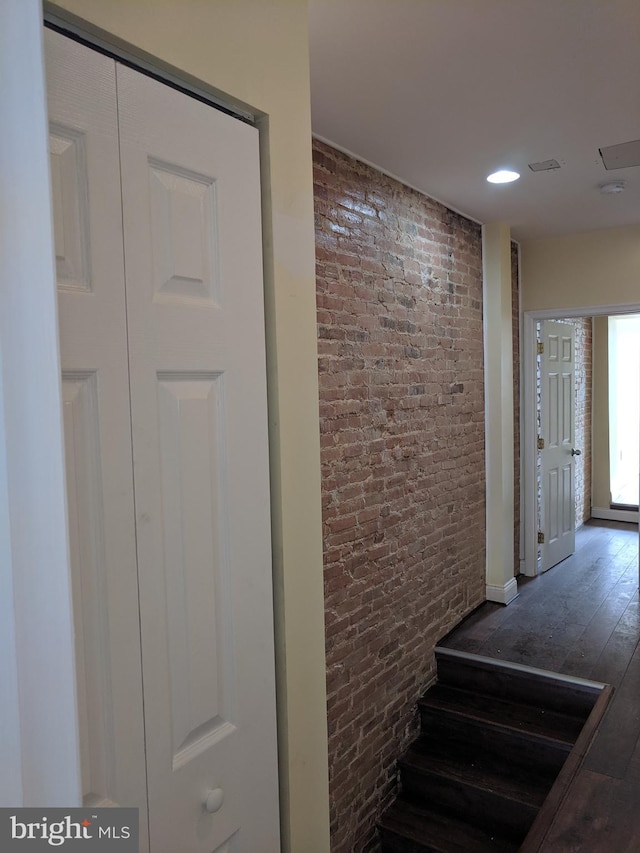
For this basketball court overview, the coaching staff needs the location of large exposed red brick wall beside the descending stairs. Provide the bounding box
[314,142,485,853]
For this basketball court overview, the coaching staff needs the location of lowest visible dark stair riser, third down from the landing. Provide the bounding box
[400,765,538,841]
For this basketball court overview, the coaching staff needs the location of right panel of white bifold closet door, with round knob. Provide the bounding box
[117,66,280,853]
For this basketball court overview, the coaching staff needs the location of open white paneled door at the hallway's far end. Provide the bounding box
[540,320,576,571]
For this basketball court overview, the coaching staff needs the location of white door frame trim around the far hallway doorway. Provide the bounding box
[520,302,640,577]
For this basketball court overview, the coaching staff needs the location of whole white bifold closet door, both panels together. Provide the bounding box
[47,28,279,853]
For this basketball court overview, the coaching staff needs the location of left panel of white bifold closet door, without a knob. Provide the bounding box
[45,30,148,851]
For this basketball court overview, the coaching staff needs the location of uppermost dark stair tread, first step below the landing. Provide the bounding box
[419,684,584,746]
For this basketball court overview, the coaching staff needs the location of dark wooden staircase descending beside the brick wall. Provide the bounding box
[378,648,610,853]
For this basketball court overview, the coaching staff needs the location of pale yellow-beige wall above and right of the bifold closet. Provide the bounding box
[45,0,329,853]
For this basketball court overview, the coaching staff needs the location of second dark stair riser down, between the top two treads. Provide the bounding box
[420,707,571,774]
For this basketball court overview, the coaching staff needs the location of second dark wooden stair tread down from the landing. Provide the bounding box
[400,735,556,809]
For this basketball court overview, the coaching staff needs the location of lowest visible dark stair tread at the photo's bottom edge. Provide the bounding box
[378,798,519,853]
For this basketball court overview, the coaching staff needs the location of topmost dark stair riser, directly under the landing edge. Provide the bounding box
[438,657,599,720]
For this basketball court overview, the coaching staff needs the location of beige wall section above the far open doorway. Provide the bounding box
[522,225,640,311]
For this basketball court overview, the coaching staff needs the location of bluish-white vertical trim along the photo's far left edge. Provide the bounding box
[0,0,82,807]
